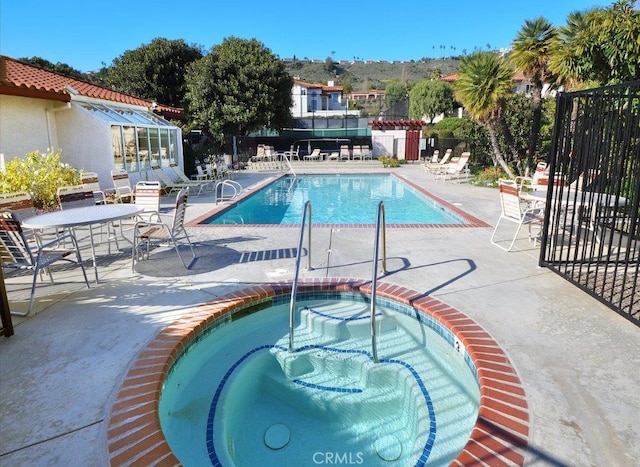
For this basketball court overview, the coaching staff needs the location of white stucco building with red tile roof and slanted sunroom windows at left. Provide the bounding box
[0,56,183,189]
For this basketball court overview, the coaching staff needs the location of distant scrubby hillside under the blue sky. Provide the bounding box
[285,58,459,90]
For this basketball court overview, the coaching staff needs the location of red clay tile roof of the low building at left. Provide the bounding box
[0,55,183,118]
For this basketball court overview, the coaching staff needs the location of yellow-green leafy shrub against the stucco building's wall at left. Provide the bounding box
[0,149,81,211]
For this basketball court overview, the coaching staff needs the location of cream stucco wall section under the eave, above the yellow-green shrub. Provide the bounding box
[0,95,61,161]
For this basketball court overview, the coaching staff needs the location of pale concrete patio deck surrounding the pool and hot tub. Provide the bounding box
[0,163,640,466]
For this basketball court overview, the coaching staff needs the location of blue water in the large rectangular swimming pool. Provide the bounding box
[205,174,464,225]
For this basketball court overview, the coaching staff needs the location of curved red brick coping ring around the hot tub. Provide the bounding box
[107,278,529,466]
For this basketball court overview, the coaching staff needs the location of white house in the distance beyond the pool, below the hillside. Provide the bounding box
[291,79,360,118]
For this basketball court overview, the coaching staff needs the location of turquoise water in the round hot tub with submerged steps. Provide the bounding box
[160,293,479,466]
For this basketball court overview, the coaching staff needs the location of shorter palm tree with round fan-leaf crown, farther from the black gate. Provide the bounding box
[453,52,522,178]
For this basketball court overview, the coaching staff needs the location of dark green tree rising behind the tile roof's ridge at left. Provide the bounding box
[104,38,202,107]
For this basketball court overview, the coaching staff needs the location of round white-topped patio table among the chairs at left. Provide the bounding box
[22,204,143,283]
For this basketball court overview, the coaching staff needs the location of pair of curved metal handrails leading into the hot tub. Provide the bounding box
[289,201,387,363]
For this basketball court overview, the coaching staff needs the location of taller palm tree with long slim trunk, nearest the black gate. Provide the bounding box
[509,17,557,174]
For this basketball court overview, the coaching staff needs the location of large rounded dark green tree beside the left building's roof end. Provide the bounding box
[186,37,293,141]
